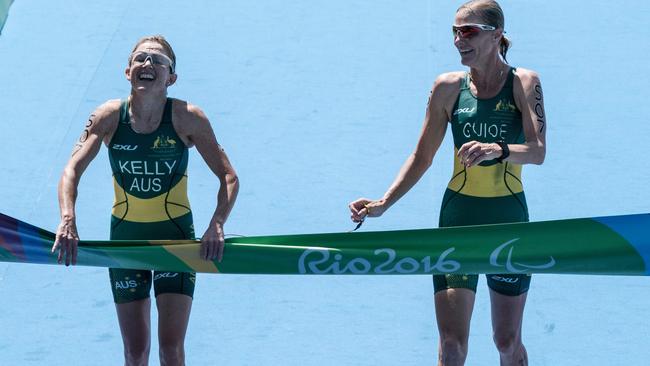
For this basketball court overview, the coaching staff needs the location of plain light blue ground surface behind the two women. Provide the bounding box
[0,0,650,365]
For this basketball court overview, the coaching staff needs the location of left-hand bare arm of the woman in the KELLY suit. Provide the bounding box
[52,102,117,266]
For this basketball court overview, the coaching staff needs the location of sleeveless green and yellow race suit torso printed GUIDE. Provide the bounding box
[440,68,528,226]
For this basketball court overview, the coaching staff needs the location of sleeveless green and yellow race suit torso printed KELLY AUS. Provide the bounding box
[108,98,194,239]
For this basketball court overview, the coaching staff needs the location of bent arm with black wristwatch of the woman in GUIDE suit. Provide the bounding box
[458,68,546,167]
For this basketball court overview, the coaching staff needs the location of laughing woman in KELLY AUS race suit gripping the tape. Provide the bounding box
[52,36,239,365]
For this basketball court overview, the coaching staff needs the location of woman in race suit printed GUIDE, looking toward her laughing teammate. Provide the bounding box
[350,0,546,365]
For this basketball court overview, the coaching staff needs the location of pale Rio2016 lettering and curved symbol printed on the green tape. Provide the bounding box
[298,238,556,274]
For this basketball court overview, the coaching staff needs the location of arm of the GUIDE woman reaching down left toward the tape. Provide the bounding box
[349,73,458,222]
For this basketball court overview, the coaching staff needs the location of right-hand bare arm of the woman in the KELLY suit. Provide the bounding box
[181,104,239,262]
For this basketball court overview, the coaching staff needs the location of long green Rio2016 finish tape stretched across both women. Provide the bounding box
[0,214,650,276]
